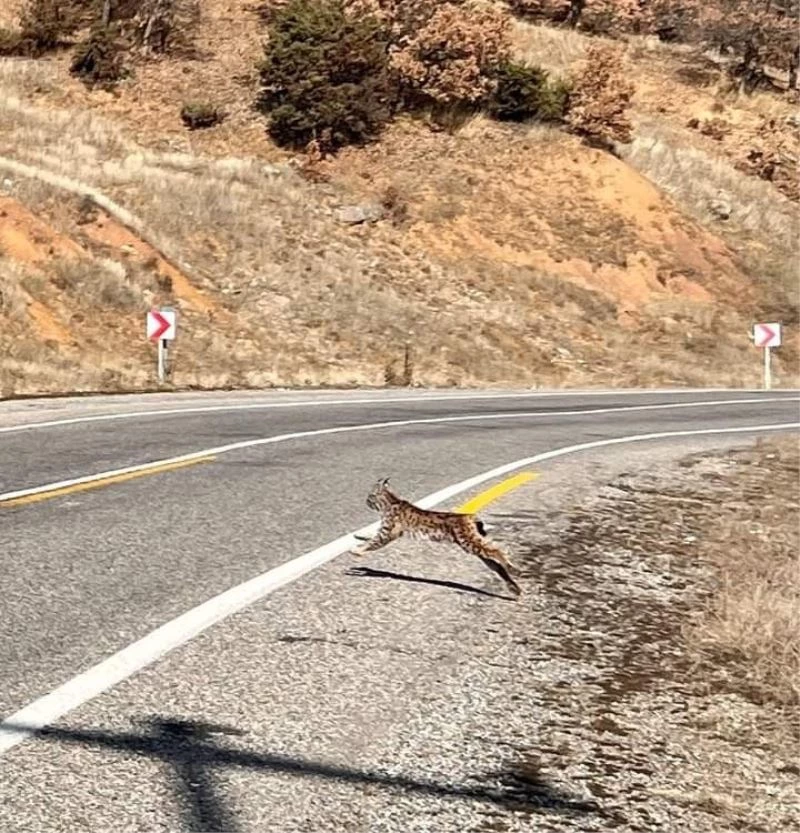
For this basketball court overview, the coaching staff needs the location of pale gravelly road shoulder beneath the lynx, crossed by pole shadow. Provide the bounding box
[0,432,800,833]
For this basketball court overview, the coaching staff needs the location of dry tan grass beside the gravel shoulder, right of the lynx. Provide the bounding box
[687,437,800,706]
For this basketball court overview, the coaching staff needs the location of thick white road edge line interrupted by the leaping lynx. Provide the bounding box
[0,422,800,755]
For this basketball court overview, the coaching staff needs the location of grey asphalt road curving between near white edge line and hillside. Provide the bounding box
[0,391,800,829]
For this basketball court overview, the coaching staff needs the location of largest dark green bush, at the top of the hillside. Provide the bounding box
[258,0,394,152]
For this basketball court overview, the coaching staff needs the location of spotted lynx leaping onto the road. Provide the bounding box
[351,477,522,596]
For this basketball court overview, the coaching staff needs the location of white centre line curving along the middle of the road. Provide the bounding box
[0,397,800,505]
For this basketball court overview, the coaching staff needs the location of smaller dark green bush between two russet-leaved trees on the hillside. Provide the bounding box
[487,63,569,122]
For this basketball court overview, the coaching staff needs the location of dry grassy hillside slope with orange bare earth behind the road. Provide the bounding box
[0,0,797,395]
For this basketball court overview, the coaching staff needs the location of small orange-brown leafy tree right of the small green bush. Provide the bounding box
[567,43,635,146]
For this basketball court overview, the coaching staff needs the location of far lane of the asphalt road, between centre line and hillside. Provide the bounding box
[0,391,792,492]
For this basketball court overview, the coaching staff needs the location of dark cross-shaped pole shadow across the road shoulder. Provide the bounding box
[5,717,604,833]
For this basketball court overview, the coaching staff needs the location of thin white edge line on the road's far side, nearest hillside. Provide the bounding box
[0,388,793,434]
